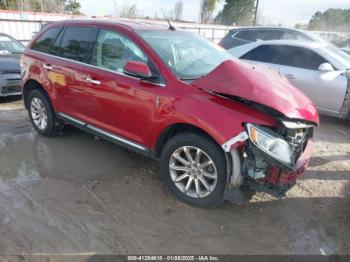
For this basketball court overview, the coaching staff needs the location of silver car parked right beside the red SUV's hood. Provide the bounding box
[229,40,350,118]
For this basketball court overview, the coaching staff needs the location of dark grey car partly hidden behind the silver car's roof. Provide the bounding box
[219,27,327,49]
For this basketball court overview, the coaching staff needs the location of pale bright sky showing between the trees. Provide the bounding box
[80,0,350,26]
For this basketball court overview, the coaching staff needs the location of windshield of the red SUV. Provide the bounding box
[138,30,234,80]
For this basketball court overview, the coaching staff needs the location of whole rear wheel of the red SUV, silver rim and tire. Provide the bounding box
[28,89,63,137]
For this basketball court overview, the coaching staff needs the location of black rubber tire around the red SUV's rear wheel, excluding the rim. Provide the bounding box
[28,90,55,136]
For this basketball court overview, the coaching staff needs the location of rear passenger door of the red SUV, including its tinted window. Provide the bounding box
[48,26,98,120]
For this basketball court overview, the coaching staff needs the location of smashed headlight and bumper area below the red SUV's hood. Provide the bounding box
[222,121,314,193]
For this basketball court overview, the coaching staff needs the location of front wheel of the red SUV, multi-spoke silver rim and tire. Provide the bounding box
[160,133,227,208]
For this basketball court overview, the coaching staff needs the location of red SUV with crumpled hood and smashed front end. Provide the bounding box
[21,19,319,207]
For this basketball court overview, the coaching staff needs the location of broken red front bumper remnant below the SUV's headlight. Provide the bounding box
[264,140,313,185]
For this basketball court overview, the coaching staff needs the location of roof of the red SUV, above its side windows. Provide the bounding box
[54,18,174,31]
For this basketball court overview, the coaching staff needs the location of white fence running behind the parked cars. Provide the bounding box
[0,10,350,47]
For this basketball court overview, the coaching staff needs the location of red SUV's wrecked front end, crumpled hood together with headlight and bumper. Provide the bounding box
[192,60,319,194]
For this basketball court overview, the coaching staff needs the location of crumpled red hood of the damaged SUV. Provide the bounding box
[192,60,319,124]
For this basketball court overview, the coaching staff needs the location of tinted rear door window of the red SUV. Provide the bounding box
[55,26,97,63]
